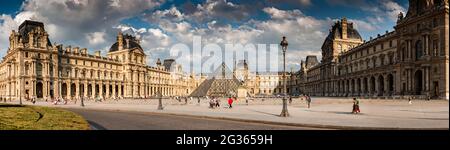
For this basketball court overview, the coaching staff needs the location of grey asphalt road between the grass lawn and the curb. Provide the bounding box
[68,109,317,130]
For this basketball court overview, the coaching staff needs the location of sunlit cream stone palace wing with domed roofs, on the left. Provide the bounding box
[0,20,198,99]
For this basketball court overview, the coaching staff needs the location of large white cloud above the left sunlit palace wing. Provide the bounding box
[2,0,163,51]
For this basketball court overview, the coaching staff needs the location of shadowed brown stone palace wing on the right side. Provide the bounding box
[296,0,449,100]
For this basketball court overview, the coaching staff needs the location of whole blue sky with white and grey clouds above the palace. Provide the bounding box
[0,0,408,72]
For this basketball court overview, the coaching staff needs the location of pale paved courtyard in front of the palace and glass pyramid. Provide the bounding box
[4,97,449,129]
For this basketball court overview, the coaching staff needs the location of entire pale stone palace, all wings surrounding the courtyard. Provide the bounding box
[0,0,449,100]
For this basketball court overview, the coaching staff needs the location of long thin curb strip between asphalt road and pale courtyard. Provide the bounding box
[65,108,449,130]
